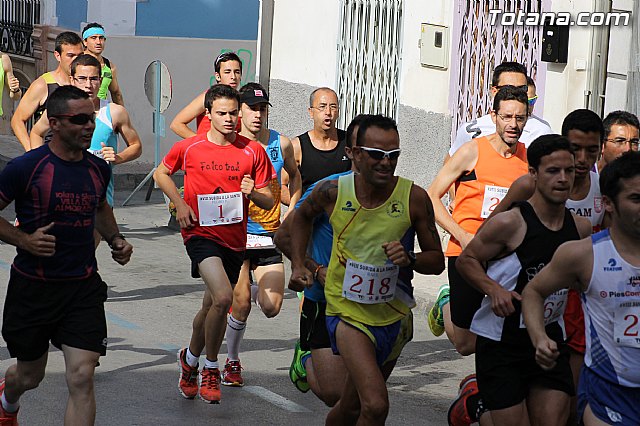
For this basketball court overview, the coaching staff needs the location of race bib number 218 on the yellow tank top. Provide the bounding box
[342,259,400,305]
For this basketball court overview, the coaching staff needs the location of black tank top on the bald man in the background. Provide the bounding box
[298,129,351,193]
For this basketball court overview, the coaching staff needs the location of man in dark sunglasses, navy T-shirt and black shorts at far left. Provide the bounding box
[0,86,133,425]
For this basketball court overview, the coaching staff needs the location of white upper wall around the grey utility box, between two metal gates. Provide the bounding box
[400,0,455,115]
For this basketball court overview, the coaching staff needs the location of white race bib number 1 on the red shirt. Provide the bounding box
[198,192,244,226]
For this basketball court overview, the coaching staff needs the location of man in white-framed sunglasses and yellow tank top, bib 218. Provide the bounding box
[290,115,444,424]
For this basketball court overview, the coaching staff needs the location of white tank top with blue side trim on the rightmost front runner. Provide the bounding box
[581,230,640,388]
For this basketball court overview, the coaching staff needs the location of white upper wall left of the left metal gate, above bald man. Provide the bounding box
[271,0,340,87]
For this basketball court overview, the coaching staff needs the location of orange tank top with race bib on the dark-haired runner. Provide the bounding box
[445,136,528,256]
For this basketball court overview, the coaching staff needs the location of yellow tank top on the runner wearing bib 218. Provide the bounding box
[324,174,413,326]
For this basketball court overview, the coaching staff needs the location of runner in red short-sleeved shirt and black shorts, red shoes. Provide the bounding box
[154,84,276,403]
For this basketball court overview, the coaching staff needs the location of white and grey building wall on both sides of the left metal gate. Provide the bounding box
[269,0,452,186]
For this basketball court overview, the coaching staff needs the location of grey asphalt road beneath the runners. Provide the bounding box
[0,190,473,425]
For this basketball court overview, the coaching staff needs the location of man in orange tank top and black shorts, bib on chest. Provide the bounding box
[428,86,528,355]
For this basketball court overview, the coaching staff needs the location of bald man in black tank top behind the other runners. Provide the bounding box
[282,87,351,201]
